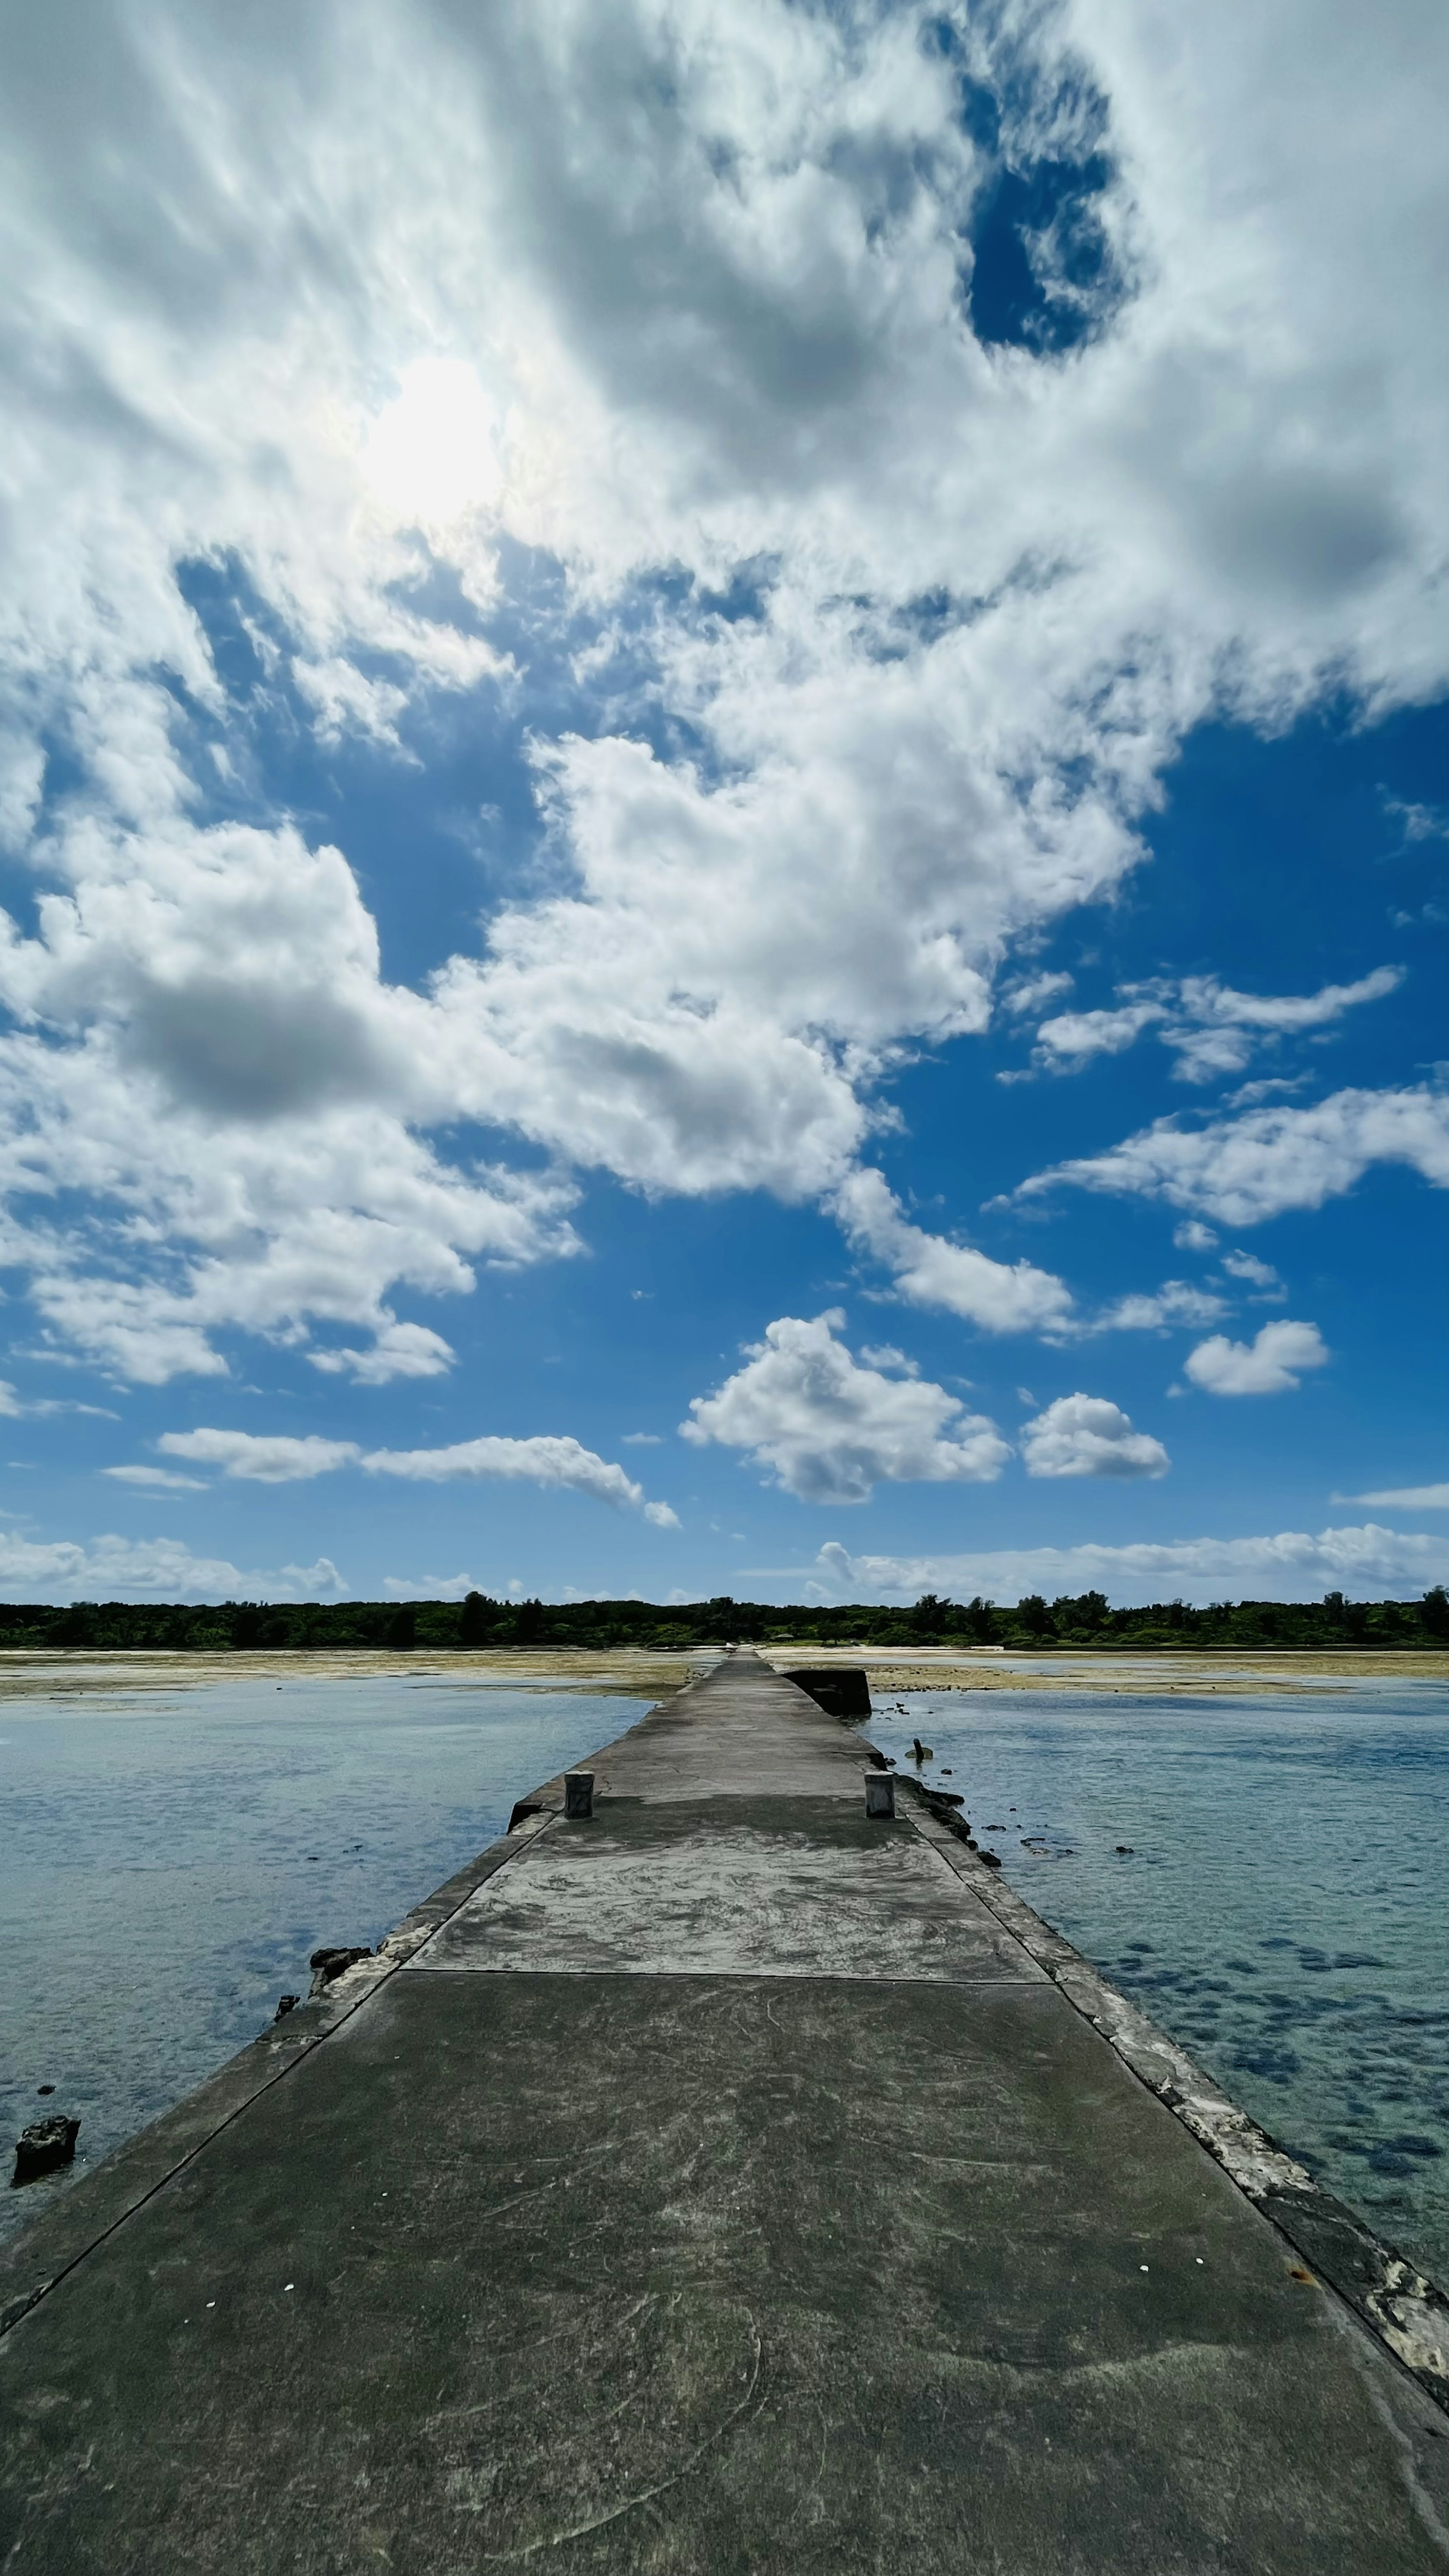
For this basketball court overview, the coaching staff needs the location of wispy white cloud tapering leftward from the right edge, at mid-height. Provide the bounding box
[1016,1084,1449,1226]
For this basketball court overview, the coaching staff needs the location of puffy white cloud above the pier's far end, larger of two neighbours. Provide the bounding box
[681,1309,1011,1502]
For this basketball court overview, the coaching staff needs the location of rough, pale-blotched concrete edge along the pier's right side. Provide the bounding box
[902,1778,1449,2414]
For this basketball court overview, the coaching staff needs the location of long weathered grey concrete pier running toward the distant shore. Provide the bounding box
[0,1654,1449,2576]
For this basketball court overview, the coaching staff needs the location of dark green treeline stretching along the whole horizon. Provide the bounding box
[11,1584,1449,1654]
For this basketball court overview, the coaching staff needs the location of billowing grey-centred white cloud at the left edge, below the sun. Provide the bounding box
[0,822,580,1383]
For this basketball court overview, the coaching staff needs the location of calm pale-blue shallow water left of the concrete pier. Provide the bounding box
[0,1675,637,2236]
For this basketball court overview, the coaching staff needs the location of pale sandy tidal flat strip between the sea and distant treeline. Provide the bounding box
[0,1638,1449,1700]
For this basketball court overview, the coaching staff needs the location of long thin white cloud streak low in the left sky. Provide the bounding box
[153,1430,678,1530]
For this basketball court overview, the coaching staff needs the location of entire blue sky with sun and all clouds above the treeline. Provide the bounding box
[0,0,1449,1600]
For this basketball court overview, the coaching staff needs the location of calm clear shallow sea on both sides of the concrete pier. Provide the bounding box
[0,1675,1449,2282]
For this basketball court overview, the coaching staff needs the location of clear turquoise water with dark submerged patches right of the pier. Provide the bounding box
[871,1682,1449,2282]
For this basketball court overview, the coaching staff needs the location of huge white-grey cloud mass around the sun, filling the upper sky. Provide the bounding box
[0,0,1444,1381]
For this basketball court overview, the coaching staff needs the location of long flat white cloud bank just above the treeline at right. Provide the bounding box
[799,1520,1449,1605]
